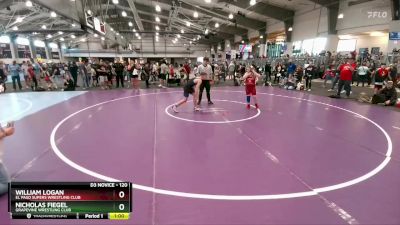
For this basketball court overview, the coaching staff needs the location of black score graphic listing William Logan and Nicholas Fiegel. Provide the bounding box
[8,182,132,220]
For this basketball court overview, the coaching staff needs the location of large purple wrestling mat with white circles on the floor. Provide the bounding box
[0,87,400,224]
